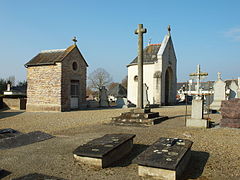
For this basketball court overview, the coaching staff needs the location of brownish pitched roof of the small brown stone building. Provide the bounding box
[25,44,88,67]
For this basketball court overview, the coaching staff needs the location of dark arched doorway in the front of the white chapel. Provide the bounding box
[164,67,173,105]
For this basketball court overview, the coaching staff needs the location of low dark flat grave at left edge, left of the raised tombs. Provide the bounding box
[0,129,54,150]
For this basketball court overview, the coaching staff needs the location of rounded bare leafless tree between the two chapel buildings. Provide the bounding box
[88,68,112,90]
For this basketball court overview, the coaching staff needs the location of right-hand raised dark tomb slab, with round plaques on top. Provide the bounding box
[136,137,193,180]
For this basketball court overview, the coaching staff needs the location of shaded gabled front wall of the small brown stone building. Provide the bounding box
[61,48,87,111]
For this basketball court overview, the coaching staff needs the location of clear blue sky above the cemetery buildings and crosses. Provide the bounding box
[0,0,240,82]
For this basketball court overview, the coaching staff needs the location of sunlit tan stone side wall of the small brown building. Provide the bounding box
[26,63,62,111]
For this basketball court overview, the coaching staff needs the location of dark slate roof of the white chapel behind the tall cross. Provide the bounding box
[128,44,161,66]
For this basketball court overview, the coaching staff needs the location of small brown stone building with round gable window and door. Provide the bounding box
[25,40,88,111]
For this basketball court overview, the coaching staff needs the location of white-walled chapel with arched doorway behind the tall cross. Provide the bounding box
[127,26,177,105]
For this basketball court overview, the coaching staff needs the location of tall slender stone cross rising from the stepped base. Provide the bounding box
[135,24,147,109]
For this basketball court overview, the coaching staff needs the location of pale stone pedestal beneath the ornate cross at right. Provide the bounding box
[186,99,208,128]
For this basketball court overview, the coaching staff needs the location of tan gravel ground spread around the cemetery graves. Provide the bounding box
[0,106,240,180]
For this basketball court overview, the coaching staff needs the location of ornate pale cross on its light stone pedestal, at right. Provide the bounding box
[186,65,208,128]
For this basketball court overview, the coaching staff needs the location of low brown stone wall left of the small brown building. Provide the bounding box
[3,98,27,110]
